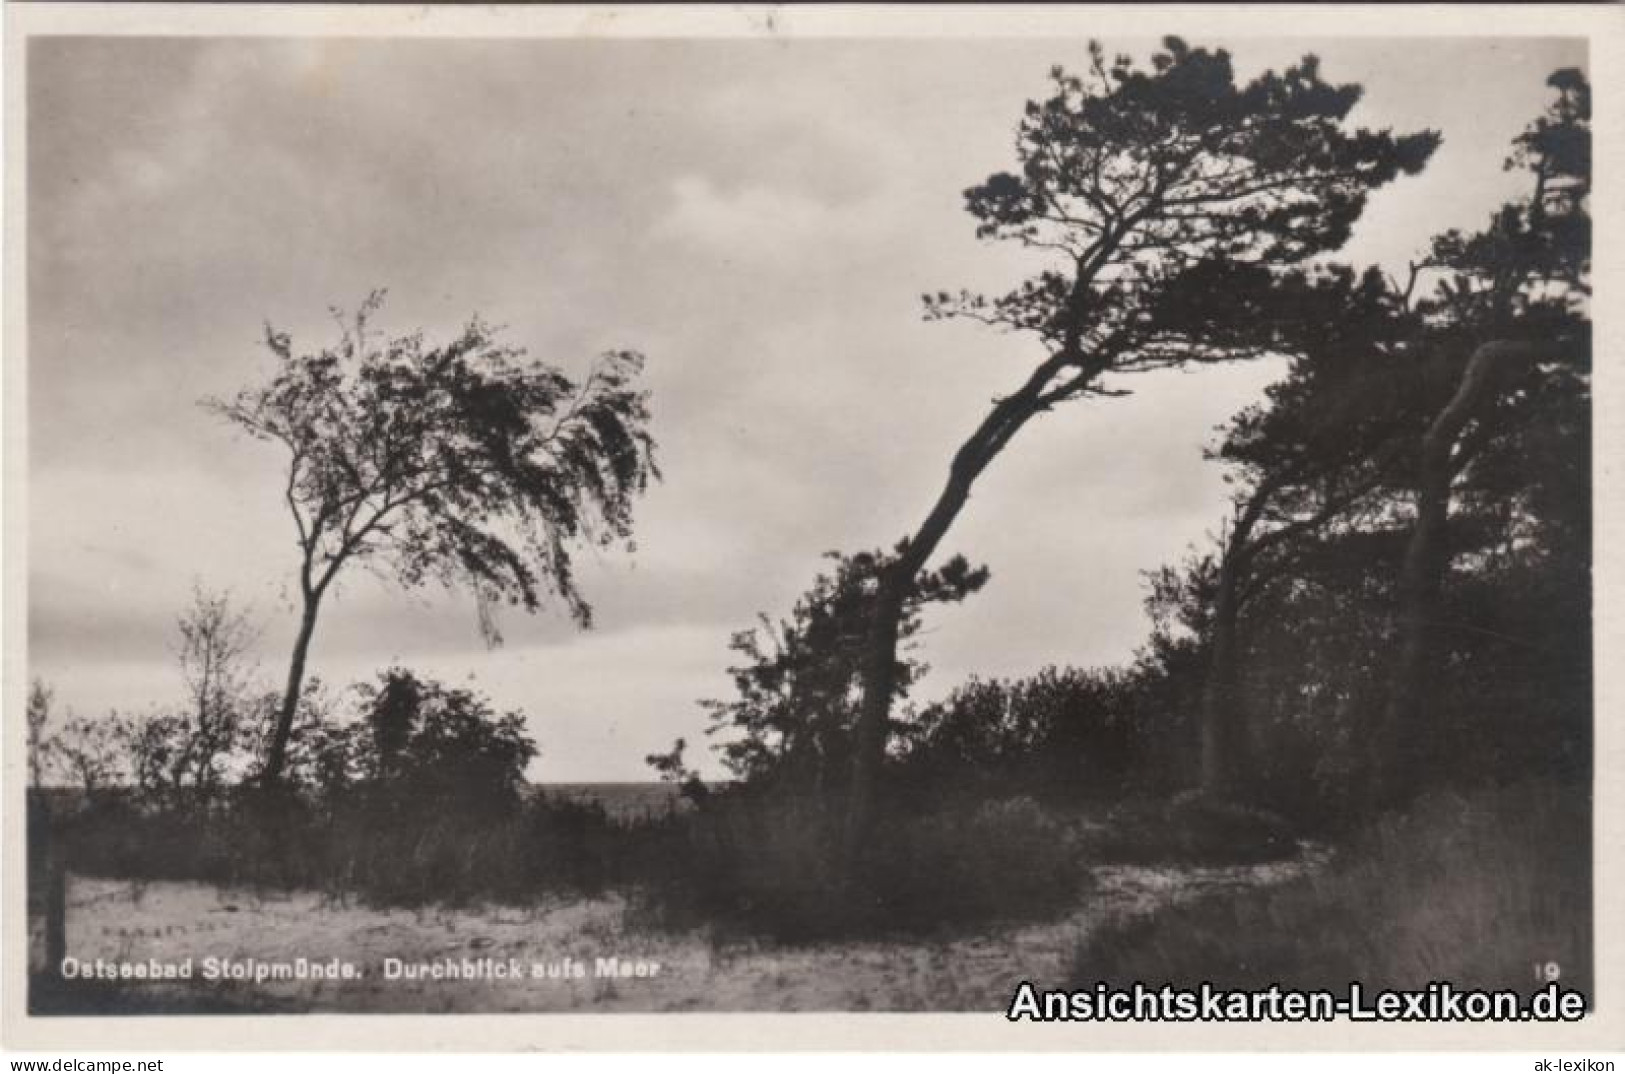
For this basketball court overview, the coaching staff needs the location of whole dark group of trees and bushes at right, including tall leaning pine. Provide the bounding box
[710,54,1591,827]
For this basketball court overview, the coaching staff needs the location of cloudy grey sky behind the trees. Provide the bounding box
[28,29,1584,780]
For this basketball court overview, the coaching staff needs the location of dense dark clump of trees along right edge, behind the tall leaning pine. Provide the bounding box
[1105,64,1591,824]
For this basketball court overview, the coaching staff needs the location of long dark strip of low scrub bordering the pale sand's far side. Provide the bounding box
[54,786,1086,941]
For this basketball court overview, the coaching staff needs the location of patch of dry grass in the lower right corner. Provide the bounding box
[1073,783,1593,991]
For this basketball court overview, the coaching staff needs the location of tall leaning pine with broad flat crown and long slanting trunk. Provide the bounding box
[848,37,1438,855]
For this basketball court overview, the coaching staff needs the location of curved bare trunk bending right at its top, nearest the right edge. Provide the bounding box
[1372,341,1534,804]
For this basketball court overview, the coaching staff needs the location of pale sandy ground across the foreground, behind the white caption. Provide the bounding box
[44,861,1313,1012]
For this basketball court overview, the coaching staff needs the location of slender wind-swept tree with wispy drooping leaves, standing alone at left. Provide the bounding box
[205,291,660,783]
